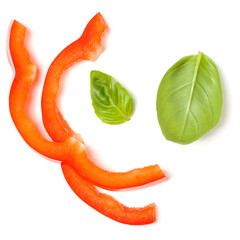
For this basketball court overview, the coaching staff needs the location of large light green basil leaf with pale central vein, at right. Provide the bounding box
[156,52,222,144]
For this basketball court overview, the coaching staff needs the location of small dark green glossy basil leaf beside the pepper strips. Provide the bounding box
[90,71,133,124]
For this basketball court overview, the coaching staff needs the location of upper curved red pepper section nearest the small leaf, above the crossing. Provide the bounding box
[42,13,108,142]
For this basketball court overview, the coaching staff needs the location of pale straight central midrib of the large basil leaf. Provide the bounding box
[180,52,203,141]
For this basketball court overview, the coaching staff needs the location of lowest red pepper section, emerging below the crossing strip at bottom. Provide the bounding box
[61,163,156,225]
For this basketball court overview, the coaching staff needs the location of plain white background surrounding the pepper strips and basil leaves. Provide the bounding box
[0,0,240,240]
